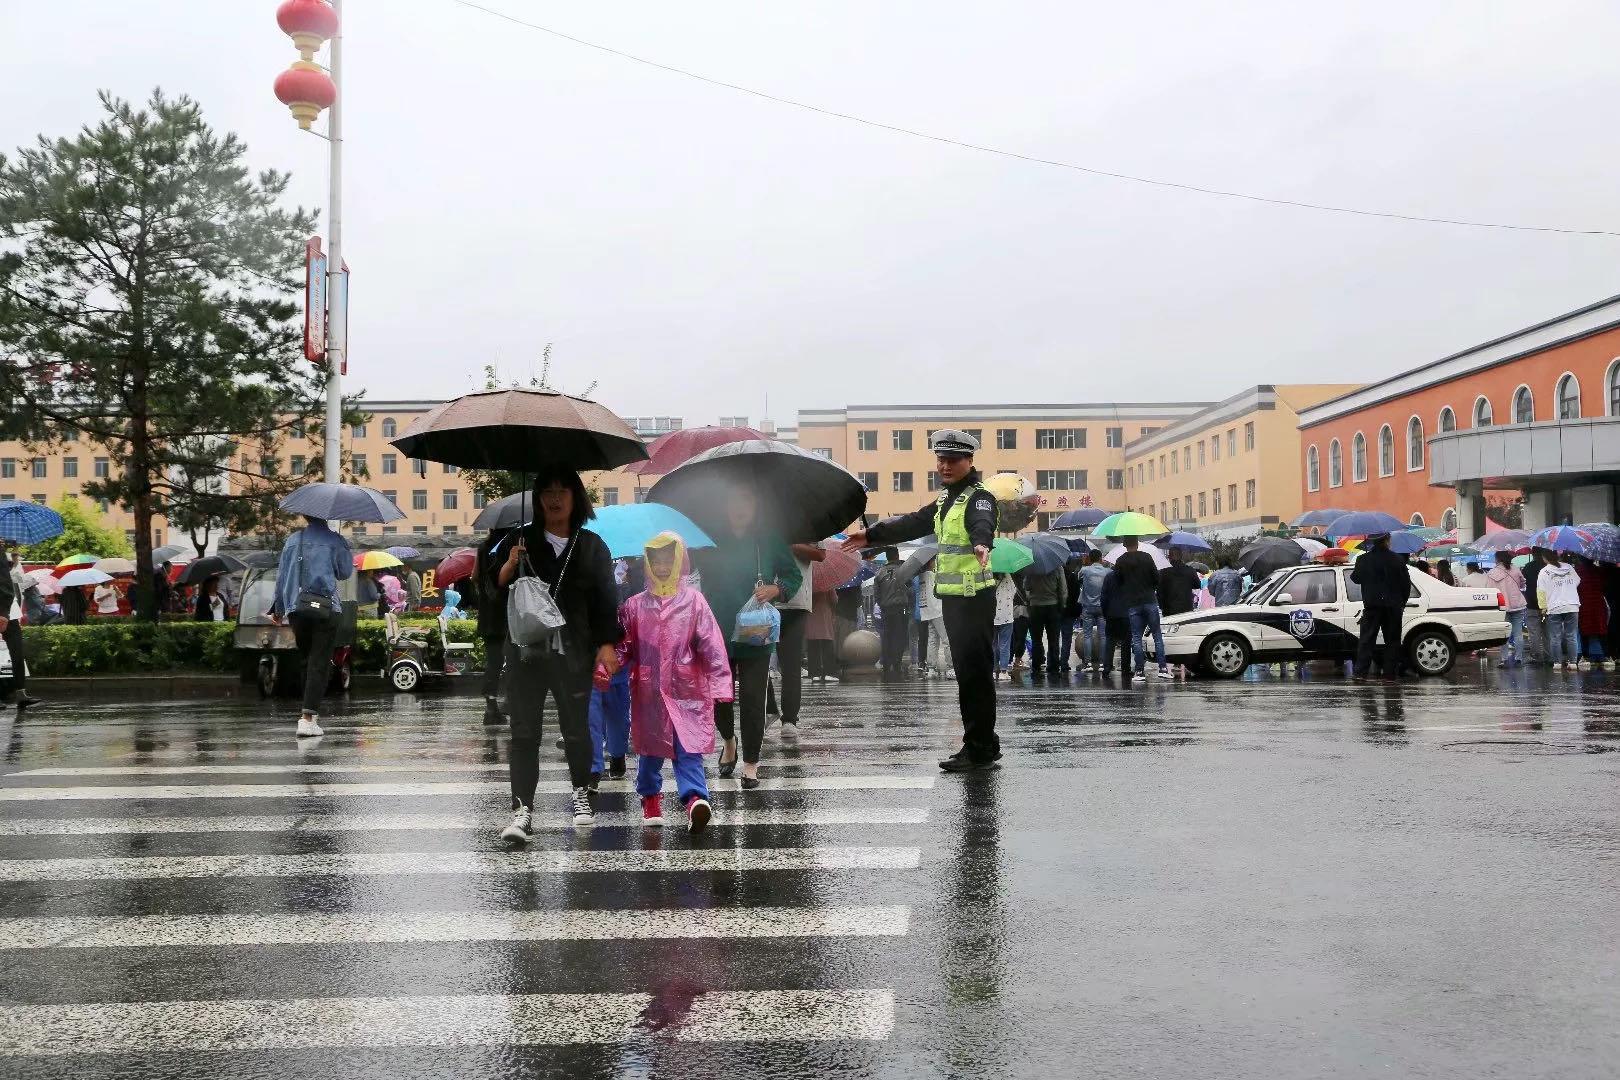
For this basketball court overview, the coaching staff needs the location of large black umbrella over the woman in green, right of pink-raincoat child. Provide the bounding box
[648,439,867,544]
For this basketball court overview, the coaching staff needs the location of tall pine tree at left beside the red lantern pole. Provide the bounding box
[0,91,326,619]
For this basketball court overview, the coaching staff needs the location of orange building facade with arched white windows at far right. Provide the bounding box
[1299,296,1620,539]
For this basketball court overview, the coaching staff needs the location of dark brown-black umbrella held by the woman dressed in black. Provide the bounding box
[394,390,646,473]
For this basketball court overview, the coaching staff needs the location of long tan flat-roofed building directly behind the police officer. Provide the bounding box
[795,402,1209,528]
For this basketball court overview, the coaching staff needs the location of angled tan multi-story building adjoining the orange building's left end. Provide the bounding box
[1119,384,1356,536]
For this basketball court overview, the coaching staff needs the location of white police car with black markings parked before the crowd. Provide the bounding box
[1147,565,1508,678]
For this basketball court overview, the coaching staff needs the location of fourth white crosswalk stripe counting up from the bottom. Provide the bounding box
[0,806,928,836]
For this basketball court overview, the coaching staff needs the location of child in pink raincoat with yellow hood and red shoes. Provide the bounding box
[619,533,732,832]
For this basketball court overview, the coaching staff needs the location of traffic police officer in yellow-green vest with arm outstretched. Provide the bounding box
[844,429,1001,772]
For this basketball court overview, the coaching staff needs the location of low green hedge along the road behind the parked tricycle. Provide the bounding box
[23,615,484,675]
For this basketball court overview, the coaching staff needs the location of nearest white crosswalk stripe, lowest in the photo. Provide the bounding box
[0,989,894,1056]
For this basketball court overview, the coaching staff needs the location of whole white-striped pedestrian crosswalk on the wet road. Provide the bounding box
[0,711,938,1077]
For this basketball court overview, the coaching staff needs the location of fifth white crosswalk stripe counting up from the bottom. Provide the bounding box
[0,774,935,803]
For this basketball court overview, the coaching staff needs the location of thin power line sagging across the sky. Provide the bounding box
[450,0,1620,236]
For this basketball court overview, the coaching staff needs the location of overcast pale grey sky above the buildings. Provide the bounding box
[0,0,1620,424]
